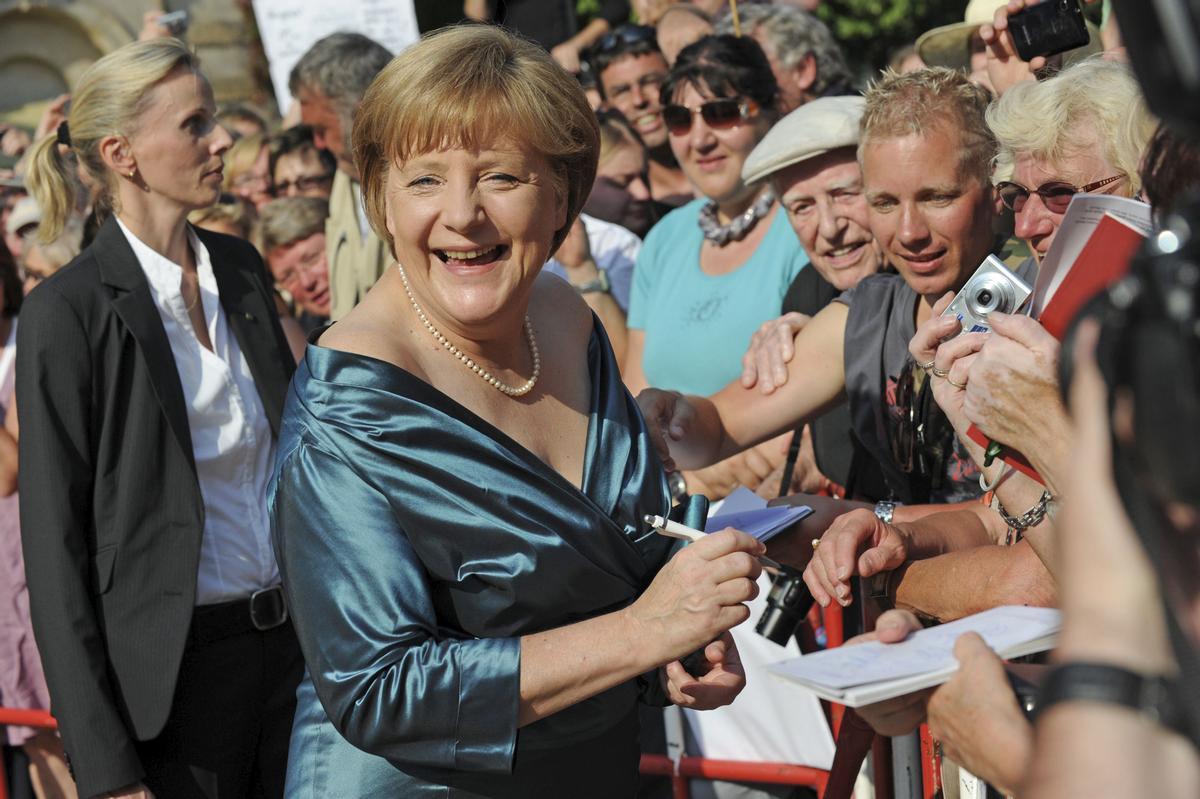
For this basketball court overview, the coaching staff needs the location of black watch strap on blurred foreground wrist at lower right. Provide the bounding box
[1036,662,1182,731]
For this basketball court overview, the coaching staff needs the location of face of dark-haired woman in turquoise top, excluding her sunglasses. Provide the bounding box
[670,84,770,204]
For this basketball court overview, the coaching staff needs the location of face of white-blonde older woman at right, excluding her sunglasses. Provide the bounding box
[1013,146,1129,264]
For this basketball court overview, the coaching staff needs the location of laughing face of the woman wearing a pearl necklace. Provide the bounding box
[386,139,566,333]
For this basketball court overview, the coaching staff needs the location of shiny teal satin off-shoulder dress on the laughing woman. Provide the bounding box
[270,323,671,799]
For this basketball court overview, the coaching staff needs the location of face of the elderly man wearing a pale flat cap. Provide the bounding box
[772,148,883,290]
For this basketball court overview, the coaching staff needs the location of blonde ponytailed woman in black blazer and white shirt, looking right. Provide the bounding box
[17,40,301,799]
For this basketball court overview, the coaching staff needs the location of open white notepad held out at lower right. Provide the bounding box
[770,606,1062,708]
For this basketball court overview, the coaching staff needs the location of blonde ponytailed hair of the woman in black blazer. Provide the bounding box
[25,38,199,242]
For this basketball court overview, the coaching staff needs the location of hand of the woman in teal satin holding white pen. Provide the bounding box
[624,528,767,665]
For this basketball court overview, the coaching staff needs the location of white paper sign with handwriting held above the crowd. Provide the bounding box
[253,0,420,114]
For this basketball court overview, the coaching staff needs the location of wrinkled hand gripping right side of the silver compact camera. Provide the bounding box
[961,313,1067,452]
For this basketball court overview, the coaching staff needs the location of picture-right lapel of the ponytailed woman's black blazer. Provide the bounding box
[197,230,292,438]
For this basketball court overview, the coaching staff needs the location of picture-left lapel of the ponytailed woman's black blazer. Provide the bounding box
[92,217,196,471]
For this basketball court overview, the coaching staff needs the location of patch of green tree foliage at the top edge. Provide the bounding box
[817,0,969,73]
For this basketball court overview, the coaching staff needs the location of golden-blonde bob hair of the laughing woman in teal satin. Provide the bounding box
[353,25,599,256]
